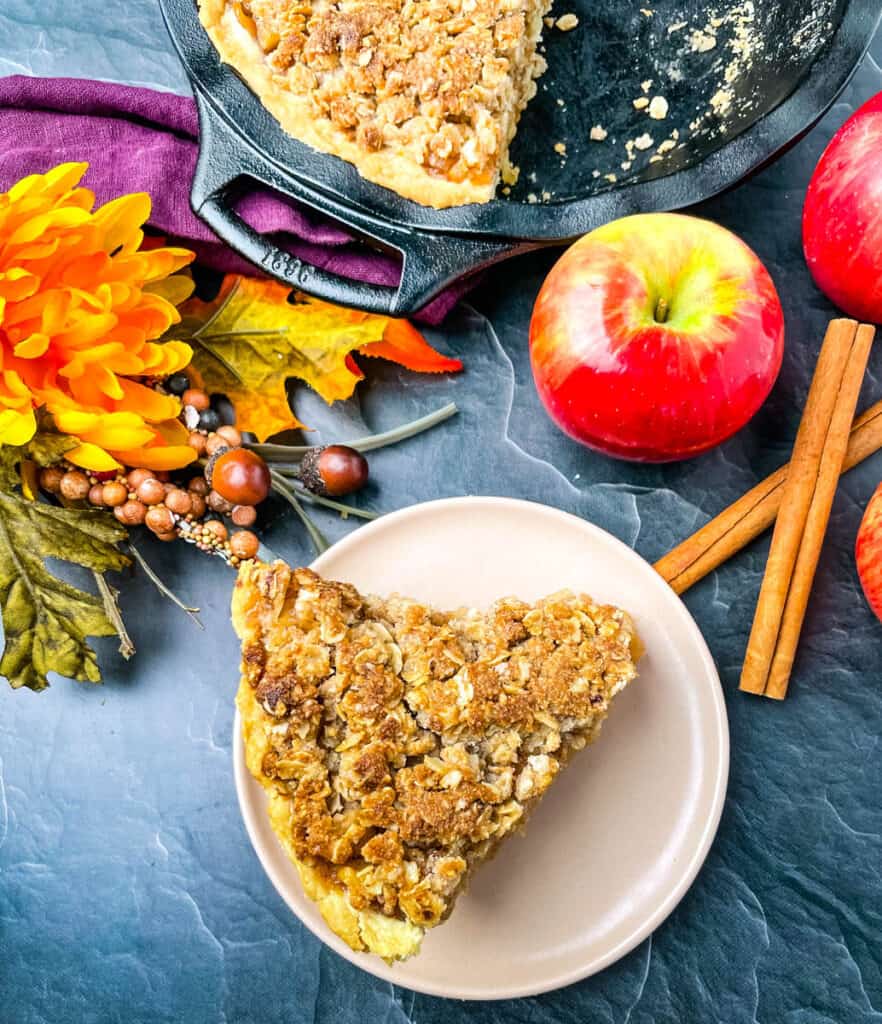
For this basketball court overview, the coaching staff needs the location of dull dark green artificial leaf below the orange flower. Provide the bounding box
[0,445,128,690]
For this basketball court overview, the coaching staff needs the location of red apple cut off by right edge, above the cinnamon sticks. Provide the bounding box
[802,92,882,324]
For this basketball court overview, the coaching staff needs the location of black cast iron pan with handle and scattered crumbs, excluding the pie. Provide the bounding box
[160,0,882,315]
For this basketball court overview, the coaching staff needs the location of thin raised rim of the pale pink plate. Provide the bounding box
[233,496,730,1001]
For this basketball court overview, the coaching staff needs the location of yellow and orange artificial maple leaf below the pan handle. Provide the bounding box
[183,274,462,441]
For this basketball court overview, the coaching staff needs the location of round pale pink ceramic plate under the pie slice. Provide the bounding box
[234,498,728,999]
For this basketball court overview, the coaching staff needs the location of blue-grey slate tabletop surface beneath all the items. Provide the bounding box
[0,8,882,1024]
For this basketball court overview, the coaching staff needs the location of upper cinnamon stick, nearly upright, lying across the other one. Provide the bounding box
[741,319,875,699]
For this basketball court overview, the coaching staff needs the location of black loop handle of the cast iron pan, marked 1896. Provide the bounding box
[191,89,536,316]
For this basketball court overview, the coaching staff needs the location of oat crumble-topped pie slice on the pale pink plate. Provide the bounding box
[233,562,639,961]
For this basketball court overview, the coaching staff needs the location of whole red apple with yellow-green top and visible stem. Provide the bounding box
[530,213,784,462]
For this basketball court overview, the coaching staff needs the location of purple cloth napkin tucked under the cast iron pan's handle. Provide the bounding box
[0,75,470,324]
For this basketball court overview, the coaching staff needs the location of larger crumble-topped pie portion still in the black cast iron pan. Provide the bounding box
[199,0,551,208]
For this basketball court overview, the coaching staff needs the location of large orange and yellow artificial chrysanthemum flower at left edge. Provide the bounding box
[0,164,195,471]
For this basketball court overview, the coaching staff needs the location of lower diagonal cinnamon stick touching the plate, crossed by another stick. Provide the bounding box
[655,401,882,594]
